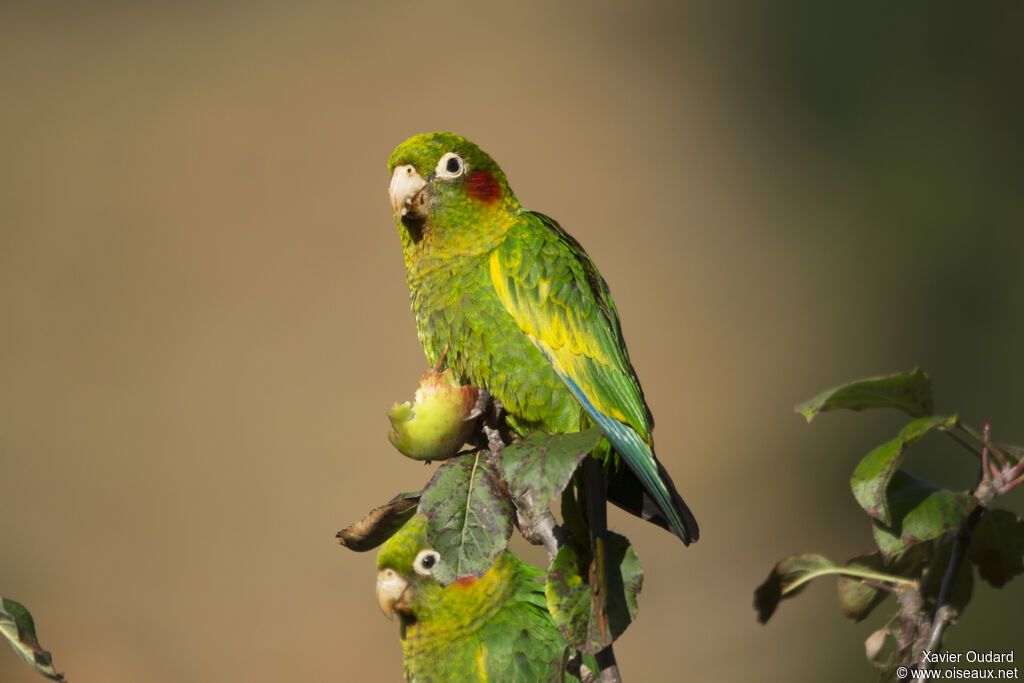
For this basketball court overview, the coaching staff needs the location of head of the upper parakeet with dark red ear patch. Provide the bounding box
[388,133,519,248]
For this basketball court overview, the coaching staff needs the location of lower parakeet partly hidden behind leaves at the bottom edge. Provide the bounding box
[377,515,567,683]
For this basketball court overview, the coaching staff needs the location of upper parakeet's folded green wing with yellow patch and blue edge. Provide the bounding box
[489,212,698,544]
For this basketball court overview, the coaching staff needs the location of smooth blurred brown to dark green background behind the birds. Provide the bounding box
[0,0,1024,683]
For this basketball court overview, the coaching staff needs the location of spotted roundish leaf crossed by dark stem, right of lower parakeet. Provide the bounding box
[545,531,643,654]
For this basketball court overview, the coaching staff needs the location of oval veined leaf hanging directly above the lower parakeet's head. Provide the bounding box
[419,452,514,586]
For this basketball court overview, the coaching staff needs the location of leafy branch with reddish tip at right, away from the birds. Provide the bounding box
[754,369,1024,681]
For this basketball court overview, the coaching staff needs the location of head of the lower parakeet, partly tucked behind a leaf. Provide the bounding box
[377,515,442,622]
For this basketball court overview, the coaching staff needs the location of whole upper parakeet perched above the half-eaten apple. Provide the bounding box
[388,133,698,545]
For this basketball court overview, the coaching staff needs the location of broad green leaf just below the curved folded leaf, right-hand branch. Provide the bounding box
[872,470,974,562]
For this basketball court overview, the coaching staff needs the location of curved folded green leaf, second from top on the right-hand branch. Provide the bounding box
[850,415,956,524]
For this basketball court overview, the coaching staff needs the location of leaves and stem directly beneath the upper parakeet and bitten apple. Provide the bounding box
[338,389,643,681]
